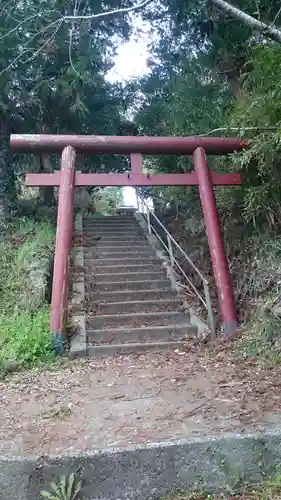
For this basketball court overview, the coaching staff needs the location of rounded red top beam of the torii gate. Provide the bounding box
[10,134,249,155]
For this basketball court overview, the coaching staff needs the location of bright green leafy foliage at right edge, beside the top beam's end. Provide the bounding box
[219,46,281,231]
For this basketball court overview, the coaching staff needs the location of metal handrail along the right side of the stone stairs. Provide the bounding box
[137,195,216,337]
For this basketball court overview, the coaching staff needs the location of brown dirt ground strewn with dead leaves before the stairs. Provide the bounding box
[0,345,281,457]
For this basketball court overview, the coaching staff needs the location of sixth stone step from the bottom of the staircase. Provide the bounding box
[85,279,171,293]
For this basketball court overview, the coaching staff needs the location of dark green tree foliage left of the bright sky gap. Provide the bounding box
[0,0,137,198]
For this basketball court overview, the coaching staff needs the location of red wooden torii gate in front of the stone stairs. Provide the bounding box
[10,134,246,350]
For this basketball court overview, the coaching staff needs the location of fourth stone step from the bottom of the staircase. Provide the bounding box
[91,298,180,315]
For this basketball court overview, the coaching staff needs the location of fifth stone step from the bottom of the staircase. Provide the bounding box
[86,286,176,304]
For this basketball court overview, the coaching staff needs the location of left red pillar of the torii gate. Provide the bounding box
[51,146,76,354]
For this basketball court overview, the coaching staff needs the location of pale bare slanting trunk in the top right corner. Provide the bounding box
[212,0,281,43]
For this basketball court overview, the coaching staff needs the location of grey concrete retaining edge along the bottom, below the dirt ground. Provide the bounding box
[0,427,281,500]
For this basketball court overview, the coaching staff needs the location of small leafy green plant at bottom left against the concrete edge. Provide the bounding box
[41,474,82,500]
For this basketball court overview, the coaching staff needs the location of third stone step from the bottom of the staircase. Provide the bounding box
[87,311,189,330]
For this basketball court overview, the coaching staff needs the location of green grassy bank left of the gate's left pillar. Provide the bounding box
[0,218,55,374]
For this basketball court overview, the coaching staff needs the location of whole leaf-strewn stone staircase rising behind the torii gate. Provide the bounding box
[83,213,197,356]
